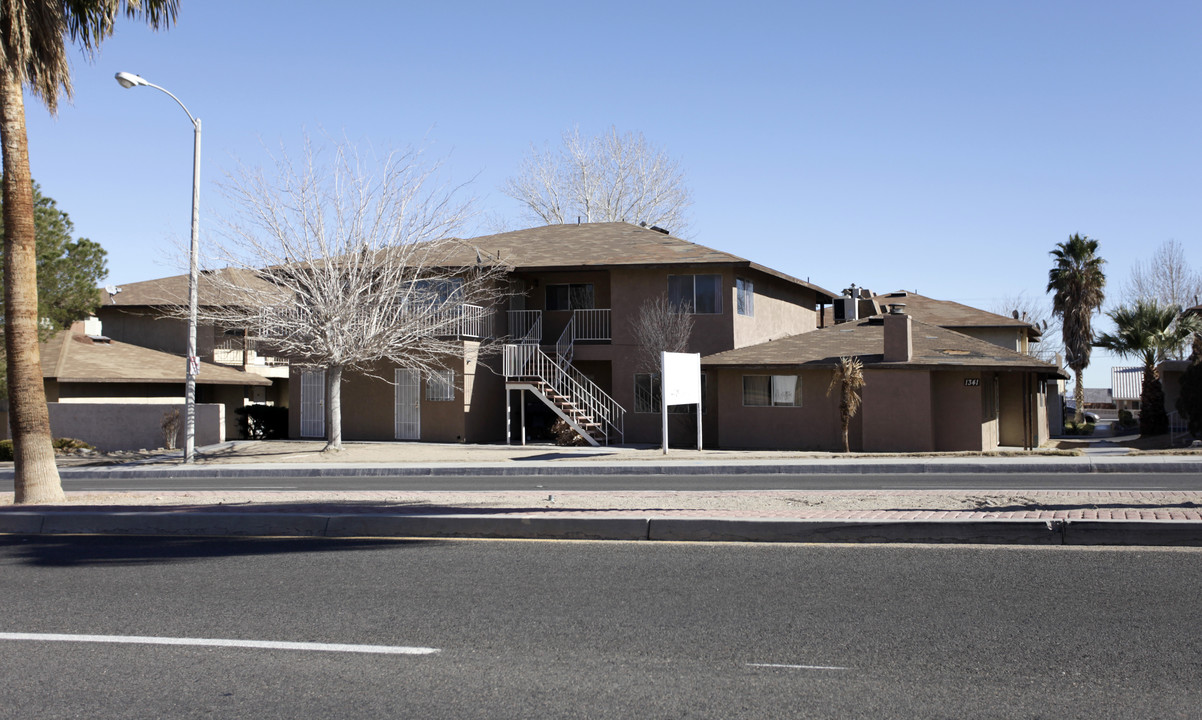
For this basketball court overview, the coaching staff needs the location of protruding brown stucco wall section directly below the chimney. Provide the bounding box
[861,369,935,452]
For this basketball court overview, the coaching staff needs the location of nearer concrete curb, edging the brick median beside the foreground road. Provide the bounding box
[7,512,1202,547]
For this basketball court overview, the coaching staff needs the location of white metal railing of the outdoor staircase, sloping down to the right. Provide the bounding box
[504,345,626,444]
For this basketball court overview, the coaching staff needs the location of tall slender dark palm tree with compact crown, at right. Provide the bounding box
[1047,234,1106,424]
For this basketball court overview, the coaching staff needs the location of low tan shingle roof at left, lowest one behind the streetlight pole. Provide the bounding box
[42,331,272,386]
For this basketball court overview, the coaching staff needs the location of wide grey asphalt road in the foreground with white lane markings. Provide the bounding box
[0,536,1202,719]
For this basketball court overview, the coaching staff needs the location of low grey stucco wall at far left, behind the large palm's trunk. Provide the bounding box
[0,403,226,452]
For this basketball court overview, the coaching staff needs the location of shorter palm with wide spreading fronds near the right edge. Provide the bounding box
[1095,301,1202,435]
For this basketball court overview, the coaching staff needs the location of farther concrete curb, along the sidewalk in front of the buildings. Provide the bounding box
[25,458,1202,480]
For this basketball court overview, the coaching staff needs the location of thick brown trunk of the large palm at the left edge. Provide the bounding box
[0,67,66,505]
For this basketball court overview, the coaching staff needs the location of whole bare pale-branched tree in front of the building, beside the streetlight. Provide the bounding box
[188,139,506,450]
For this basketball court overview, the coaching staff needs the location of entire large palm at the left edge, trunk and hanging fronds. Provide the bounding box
[0,0,179,504]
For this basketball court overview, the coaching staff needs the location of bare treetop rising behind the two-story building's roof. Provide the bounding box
[502,127,692,237]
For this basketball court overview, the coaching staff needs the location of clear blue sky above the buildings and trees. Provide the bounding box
[26,0,1202,387]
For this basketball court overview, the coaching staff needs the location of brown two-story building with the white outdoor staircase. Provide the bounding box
[290,222,832,442]
